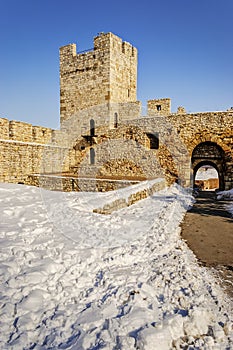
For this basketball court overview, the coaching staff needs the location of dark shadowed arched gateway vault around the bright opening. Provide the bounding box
[192,141,225,190]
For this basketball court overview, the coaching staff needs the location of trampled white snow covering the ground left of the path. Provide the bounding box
[0,184,233,350]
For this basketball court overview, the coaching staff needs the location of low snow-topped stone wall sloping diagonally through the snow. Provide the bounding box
[93,179,166,214]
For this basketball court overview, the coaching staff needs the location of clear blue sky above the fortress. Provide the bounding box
[0,0,233,128]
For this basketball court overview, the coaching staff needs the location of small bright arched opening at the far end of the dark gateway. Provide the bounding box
[194,164,219,191]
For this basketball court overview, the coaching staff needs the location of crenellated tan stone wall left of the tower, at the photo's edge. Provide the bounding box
[0,118,75,184]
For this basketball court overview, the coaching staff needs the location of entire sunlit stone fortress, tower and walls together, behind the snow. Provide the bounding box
[0,33,233,191]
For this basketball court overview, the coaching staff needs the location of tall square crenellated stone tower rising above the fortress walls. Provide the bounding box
[60,33,137,123]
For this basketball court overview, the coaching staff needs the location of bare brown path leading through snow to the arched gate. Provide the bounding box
[181,191,233,297]
